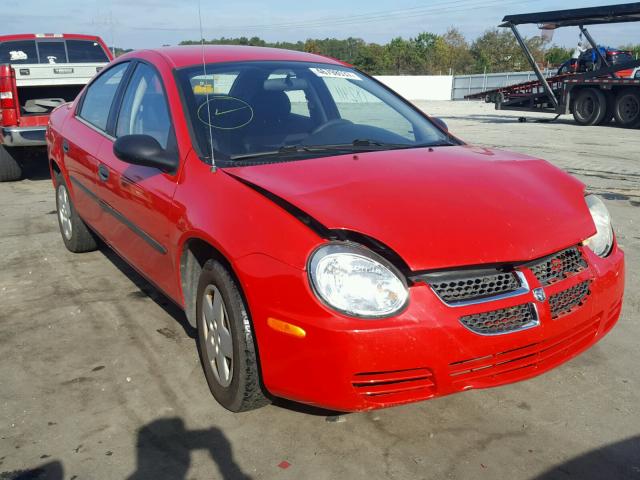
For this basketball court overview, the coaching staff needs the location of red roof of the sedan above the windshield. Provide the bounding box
[125,45,349,68]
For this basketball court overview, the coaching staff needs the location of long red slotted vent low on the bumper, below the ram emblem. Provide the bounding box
[449,314,602,389]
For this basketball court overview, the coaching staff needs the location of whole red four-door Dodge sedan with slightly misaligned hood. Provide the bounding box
[47,46,624,411]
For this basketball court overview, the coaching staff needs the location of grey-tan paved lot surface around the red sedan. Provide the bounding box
[0,102,640,480]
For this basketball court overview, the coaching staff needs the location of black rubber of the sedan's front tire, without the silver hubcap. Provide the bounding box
[196,260,257,412]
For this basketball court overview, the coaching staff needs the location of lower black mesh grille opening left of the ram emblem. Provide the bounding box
[460,303,538,335]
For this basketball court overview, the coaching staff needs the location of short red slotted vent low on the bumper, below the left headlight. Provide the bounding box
[351,368,436,402]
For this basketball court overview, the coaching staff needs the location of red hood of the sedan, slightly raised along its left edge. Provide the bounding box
[227,146,595,271]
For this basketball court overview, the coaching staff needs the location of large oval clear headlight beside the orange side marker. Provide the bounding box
[309,243,409,318]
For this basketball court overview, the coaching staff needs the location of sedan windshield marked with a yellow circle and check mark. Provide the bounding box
[179,62,458,166]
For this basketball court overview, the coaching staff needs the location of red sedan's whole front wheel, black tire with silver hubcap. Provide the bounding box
[196,260,269,412]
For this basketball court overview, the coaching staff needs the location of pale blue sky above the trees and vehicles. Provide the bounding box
[5,0,640,49]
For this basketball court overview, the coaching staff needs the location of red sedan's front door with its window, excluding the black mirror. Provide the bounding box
[90,62,179,294]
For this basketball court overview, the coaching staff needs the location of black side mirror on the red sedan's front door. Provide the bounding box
[113,135,178,173]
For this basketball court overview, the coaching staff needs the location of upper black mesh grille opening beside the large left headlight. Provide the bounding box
[427,270,521,303]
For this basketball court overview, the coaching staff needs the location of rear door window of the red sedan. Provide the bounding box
[78,62,129,131]
